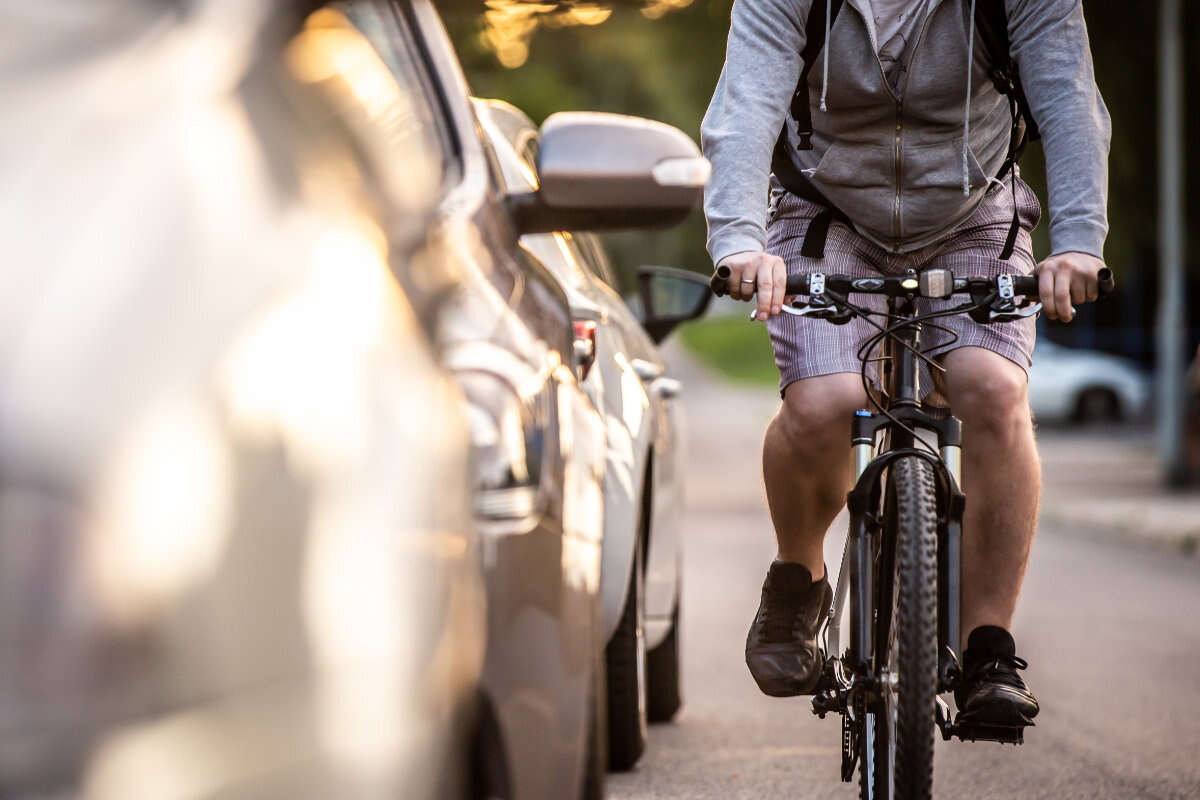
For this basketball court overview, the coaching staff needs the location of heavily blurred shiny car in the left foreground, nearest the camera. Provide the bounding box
[0,1,485,800]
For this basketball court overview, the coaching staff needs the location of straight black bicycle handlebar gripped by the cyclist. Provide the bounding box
[708,266,1115,299]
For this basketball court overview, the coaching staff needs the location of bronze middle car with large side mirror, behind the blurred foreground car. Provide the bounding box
[364,0,708,800]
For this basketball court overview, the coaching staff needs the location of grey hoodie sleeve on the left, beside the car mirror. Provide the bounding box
[701,0,812,264]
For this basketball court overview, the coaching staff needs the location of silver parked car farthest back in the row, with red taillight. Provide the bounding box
[475,100,712,770]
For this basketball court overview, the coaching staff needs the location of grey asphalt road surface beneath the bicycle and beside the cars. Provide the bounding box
[610,357,1200,800]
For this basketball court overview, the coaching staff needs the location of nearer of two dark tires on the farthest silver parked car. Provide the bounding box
[605,536,646,772]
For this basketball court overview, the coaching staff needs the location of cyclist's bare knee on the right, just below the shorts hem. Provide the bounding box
[946,348,1031,437]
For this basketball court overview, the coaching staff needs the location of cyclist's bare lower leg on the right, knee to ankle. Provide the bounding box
[946,348,1042,636]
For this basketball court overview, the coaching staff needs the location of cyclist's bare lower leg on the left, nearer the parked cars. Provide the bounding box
[762,373,866,578]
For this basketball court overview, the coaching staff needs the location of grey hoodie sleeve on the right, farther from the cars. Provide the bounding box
[1004,0,1111,258]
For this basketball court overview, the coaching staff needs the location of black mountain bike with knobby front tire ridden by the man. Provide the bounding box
[710,267,1114,800]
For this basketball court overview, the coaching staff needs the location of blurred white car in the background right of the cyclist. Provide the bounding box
[1030,337,1151,422]
